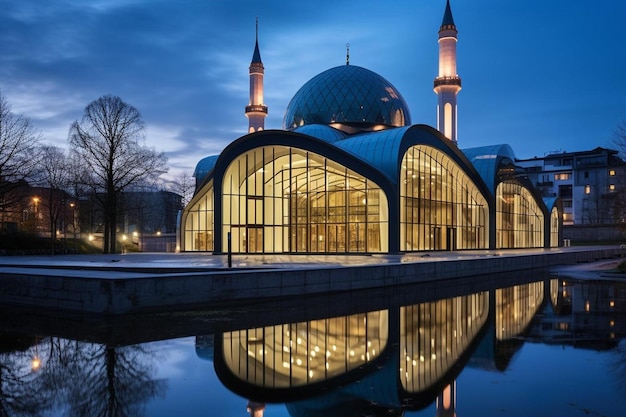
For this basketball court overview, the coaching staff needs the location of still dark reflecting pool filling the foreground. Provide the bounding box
[0,272,626,417]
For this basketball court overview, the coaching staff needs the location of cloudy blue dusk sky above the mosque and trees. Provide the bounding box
[0,0,626,180]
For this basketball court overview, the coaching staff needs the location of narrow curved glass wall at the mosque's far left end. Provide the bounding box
[181,181,215,251]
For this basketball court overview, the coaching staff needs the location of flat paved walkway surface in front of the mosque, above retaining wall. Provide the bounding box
[0,246,626,278]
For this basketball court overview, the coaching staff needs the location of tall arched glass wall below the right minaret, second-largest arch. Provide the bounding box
[400,145,489,251]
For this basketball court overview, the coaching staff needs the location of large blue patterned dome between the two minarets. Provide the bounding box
[283,65,411,130]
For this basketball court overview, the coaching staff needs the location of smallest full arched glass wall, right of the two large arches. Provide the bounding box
[496,181,544,249]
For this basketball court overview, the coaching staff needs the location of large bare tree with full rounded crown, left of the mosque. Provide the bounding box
[69,95,167,253]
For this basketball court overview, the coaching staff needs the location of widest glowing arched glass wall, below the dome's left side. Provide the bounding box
[223,146,389,253]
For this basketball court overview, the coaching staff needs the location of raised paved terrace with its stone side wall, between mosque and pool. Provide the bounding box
[0,246,624,314]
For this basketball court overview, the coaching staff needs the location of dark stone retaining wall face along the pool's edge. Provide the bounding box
[0,247,624,314]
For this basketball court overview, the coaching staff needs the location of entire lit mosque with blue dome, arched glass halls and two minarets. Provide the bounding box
[180,0,562,254]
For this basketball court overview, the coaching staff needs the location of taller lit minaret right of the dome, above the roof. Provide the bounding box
[434,0,461,143]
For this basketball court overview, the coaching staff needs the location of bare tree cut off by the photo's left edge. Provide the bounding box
[0,92,40,221]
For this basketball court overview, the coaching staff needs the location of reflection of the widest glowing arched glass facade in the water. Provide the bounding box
[222,310,389,388]
